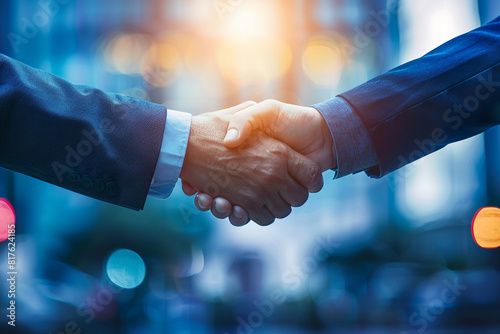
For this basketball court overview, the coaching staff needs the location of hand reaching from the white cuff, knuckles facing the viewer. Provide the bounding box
[181,104,323,225]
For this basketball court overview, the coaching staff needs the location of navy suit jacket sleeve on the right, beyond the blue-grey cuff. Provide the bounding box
[316,17,500,177]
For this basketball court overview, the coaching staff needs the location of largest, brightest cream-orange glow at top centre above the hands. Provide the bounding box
[215,1,292,85]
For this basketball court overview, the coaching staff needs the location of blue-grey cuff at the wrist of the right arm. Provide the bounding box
[312,96,378,178]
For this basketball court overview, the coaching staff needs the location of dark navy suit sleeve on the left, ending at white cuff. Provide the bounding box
[0,55,166,210]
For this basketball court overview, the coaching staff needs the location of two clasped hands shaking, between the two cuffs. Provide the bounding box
[180,100,336,226]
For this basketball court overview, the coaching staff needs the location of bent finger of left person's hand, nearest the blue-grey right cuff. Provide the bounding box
[288,149,323,192]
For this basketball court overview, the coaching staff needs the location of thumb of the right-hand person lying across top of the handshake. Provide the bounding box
[224,100,279,148]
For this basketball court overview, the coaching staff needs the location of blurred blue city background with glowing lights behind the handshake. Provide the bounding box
[0,0,500,334]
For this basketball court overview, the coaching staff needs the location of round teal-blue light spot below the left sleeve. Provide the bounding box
[106,249,146,289]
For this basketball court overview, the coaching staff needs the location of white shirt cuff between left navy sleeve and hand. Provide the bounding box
[148,110,191,199]
